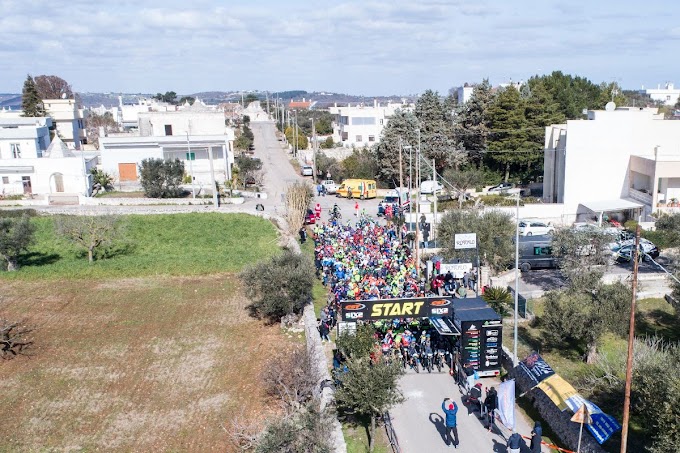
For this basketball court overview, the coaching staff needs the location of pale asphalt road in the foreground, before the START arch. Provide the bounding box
[390,371,548,453]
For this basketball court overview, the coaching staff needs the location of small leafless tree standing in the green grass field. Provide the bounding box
[55,215,123,264]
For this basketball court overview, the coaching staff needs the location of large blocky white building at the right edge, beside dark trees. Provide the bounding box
[543,108,680,220]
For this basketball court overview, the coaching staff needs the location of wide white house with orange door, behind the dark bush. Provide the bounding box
[99,103,234,185]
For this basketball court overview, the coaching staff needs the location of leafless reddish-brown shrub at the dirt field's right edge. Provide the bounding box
[262,347,316,412]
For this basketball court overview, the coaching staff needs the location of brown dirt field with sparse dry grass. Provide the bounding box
[0,274,293,452]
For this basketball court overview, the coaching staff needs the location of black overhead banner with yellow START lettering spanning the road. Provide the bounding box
[340,297,453,321]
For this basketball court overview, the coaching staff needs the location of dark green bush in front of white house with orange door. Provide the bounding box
[139,159,184,198]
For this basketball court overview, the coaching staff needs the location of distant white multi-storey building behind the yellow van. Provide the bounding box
[330,101,413,148]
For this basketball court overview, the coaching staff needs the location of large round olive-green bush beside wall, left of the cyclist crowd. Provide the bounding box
[240,250,314,322]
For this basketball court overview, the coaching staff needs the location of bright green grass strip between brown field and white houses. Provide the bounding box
[0,213,277,280]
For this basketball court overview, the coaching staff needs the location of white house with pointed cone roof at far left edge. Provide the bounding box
[0,117,96,196]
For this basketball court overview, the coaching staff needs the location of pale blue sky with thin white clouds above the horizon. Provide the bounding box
[0,0,680,96]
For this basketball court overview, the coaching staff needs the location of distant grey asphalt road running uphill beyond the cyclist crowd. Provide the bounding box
[246,121,378,221]
